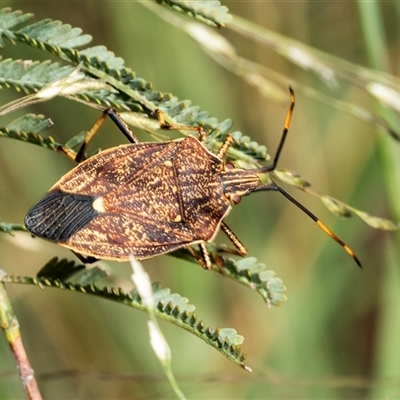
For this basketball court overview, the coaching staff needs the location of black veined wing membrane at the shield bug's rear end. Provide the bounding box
[24,189,98,242]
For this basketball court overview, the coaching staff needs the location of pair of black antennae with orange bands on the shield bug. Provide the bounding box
[254,87,362,268]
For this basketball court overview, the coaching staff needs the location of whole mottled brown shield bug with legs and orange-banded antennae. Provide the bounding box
[24,89,361,269]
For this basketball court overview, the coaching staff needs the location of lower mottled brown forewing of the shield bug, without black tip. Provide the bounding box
[60,213,196,261]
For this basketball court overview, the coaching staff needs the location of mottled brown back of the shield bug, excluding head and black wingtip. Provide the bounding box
[53,137,230,260]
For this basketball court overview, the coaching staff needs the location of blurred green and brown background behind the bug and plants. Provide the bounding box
[0,1,400,399]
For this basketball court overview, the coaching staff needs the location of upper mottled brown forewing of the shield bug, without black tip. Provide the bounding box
[53,142,176,196]
